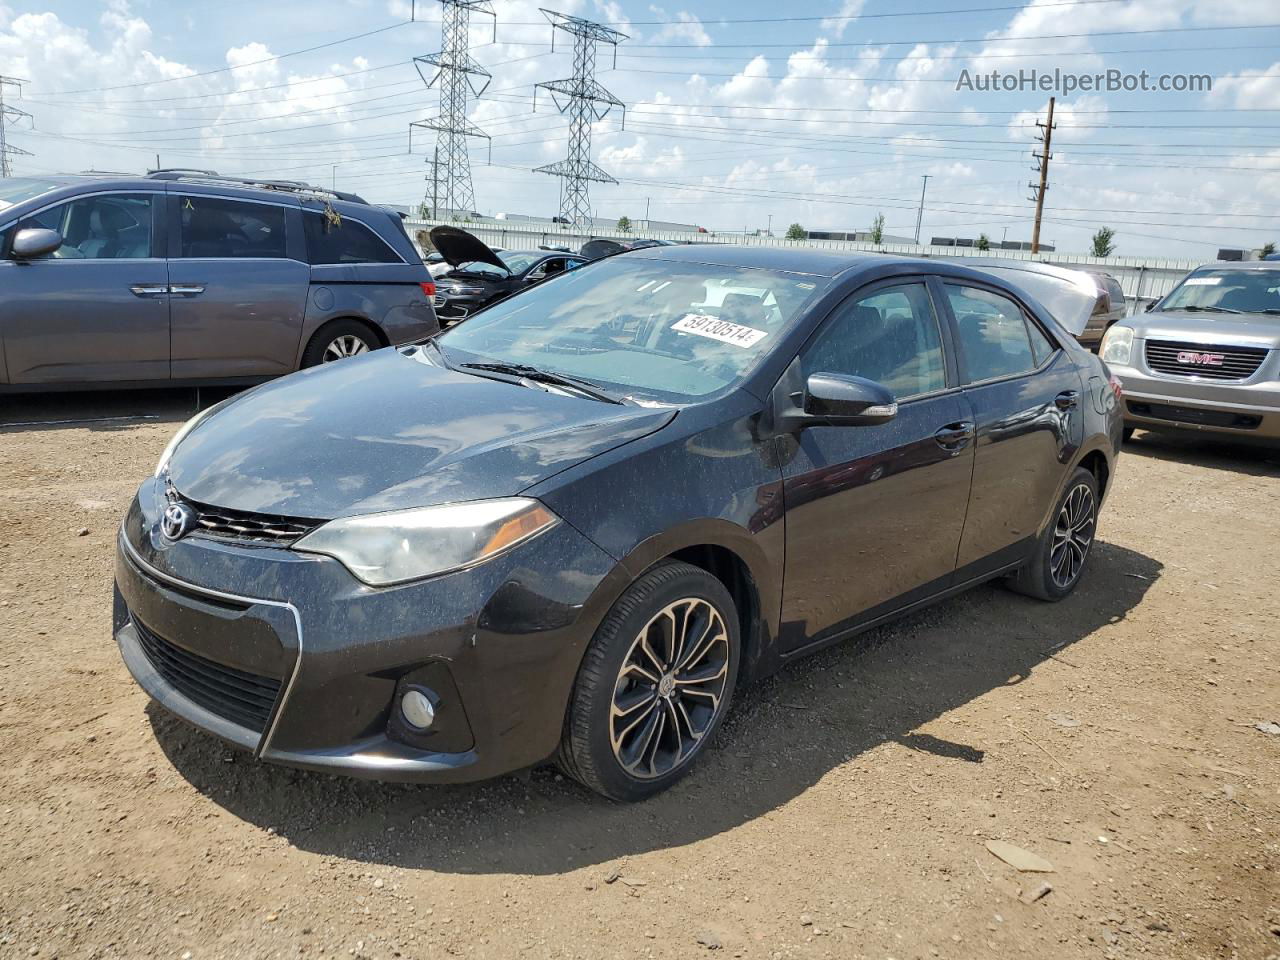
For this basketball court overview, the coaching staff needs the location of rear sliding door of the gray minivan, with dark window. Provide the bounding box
[169,192,311,380]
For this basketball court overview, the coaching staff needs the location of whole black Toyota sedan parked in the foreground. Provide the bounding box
[114,246,1121,800]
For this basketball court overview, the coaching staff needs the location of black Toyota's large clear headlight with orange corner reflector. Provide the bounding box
[293,497,558,586]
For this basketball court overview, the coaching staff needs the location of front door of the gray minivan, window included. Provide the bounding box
[0,191,169,384]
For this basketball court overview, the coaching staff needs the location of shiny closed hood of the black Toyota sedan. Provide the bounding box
[169,347,676,520]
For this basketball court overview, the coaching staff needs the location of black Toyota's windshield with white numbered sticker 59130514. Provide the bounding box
[436,257,828,403]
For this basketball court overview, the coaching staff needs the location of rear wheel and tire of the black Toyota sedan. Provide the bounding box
[1010,467,1098,602]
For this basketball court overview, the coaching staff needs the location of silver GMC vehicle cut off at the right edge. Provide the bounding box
[1101,261,1280,444]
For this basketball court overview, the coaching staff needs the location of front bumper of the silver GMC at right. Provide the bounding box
[1111,364,1280,443]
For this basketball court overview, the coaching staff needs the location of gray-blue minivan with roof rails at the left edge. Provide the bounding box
[0,170,439,392]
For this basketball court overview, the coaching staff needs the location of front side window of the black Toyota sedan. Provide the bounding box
[800,283,947,399]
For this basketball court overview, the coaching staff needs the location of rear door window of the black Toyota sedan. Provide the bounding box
[945,283,1052,383]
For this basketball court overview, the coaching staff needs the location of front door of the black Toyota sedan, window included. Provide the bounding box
[782,279,973,649]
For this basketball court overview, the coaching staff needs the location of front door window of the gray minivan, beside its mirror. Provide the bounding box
[18,193,151,260]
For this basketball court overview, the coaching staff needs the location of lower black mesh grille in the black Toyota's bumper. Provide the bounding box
[133,618,280,733]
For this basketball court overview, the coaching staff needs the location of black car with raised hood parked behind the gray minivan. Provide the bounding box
[431,227,584,326]
